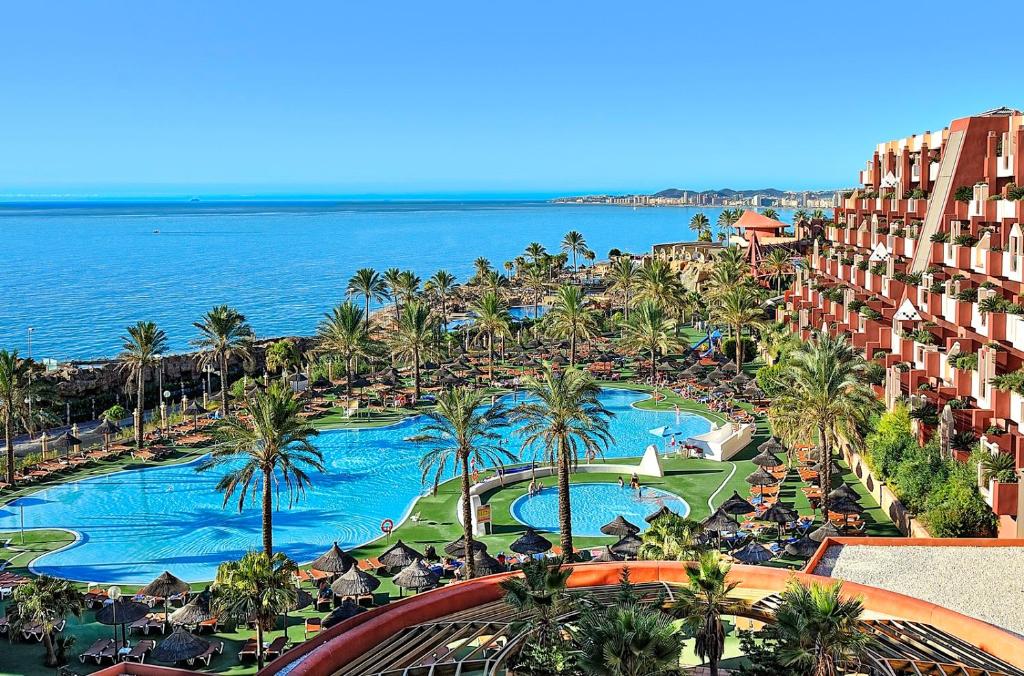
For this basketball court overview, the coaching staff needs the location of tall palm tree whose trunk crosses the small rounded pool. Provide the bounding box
[513,364,614,558]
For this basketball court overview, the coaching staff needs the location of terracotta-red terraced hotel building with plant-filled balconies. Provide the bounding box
[786,109,1024,538]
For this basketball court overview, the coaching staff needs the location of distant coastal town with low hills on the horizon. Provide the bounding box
[553,187,844,209]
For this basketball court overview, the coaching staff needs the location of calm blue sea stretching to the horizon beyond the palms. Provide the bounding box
[0,202,790,360]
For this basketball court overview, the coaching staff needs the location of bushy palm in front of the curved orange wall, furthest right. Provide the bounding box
[774,580,874,676]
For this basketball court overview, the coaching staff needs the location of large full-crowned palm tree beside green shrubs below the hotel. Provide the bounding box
[768,334,881,517]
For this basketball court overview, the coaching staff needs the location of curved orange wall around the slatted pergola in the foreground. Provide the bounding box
[261,561,1024,676]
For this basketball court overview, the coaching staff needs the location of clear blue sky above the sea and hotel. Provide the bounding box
[0,0,1024,195]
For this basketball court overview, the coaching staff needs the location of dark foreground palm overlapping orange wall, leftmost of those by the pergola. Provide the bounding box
[498,556,573,674]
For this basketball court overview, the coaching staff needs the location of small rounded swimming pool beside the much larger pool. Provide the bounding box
[510,483,690,537]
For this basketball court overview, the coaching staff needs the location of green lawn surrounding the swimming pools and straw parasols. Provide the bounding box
[0,383,899,676]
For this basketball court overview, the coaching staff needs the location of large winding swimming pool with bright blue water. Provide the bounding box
[0,389,711,583]
